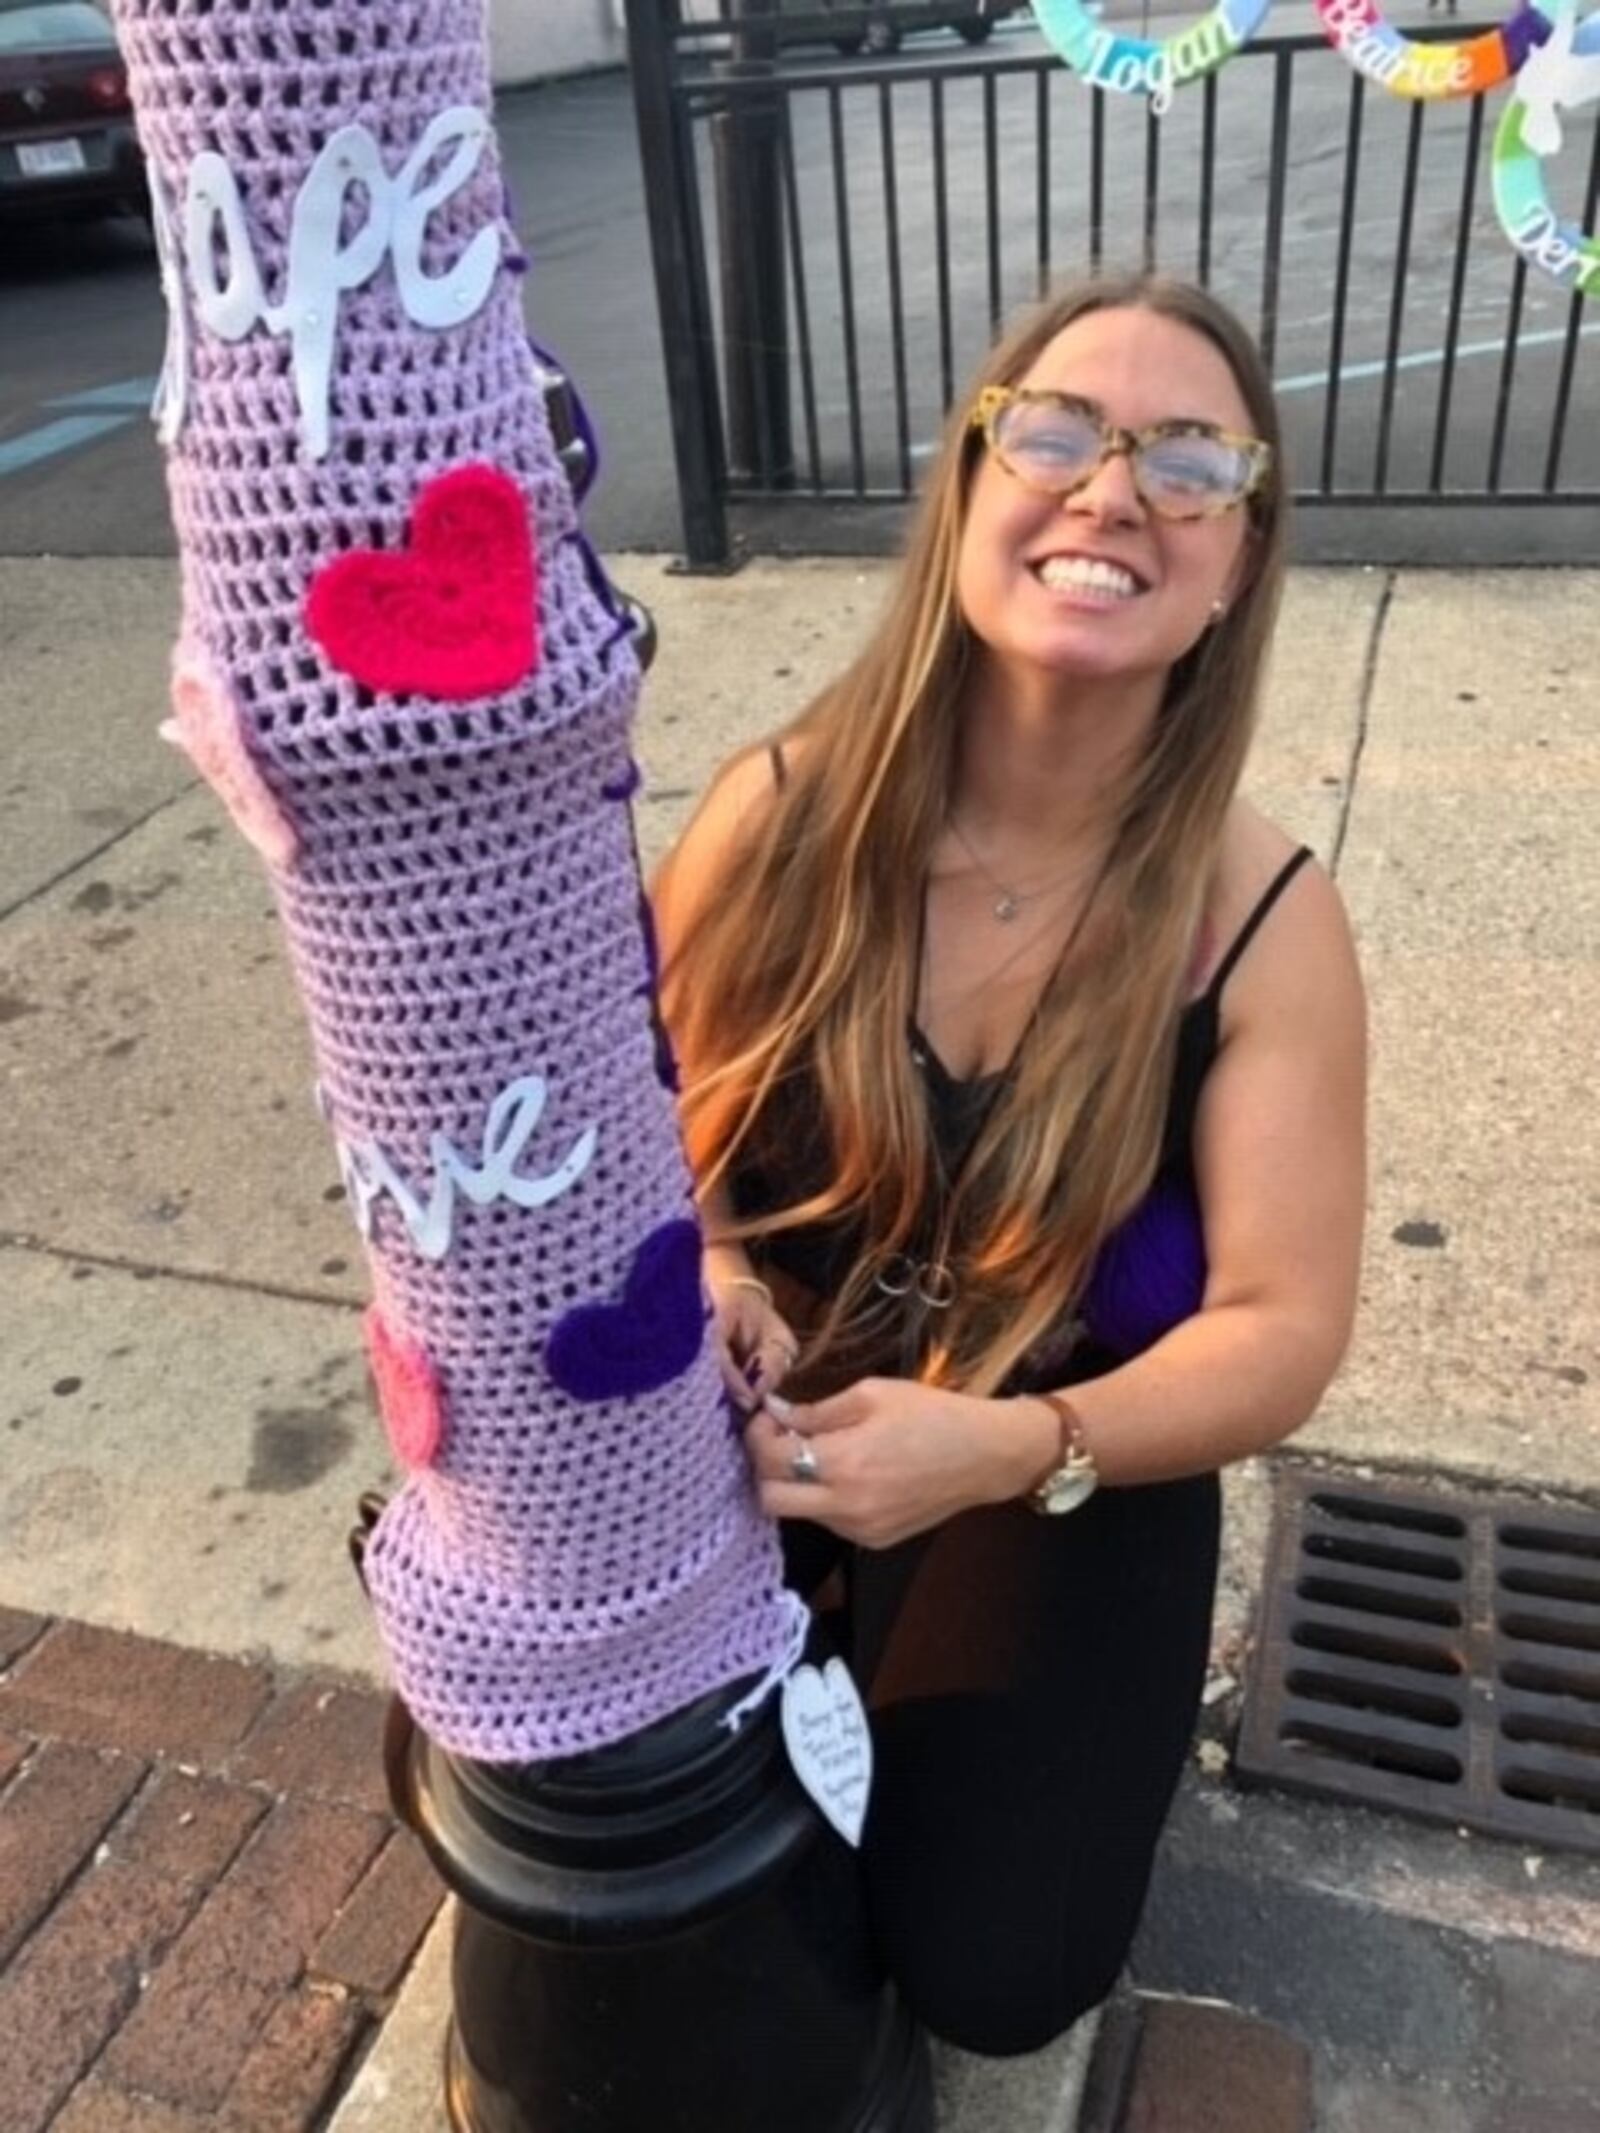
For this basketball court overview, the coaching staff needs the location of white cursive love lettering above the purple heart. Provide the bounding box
[335,1073,597,1258]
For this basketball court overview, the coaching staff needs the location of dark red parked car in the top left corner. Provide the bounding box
[0,0,149,218]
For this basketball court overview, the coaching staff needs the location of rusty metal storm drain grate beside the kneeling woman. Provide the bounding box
[1237,1470,1600,1851]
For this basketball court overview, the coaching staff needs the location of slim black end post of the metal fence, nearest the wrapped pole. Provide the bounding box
[627,0,730,570]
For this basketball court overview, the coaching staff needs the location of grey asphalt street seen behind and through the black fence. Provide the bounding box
[0,0,1600,555]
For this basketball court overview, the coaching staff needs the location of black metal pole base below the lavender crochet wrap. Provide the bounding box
[388,1687,934,2133]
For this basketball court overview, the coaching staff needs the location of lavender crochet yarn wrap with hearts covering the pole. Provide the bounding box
[113,0,804,1762]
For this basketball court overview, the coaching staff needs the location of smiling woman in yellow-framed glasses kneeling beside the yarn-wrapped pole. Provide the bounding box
[657,277,1363,2052]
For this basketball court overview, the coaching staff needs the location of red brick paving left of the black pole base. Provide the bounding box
[0,1608,442,2133]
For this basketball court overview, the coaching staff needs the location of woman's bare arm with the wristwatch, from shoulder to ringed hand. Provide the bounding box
[751,868,1365,1546]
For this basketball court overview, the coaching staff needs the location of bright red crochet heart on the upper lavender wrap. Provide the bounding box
[305,467,540,704]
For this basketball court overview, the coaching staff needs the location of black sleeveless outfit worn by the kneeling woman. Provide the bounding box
[732,831,1308,2054]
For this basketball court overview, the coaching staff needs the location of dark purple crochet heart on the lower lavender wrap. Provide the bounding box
[544,1220,706,1399]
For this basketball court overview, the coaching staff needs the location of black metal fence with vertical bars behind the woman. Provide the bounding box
[629,0,1600,567]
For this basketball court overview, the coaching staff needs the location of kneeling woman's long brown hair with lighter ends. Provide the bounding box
[661,275,1284,1393]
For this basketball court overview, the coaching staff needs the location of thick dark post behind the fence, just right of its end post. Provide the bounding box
[710,0,794,488]
